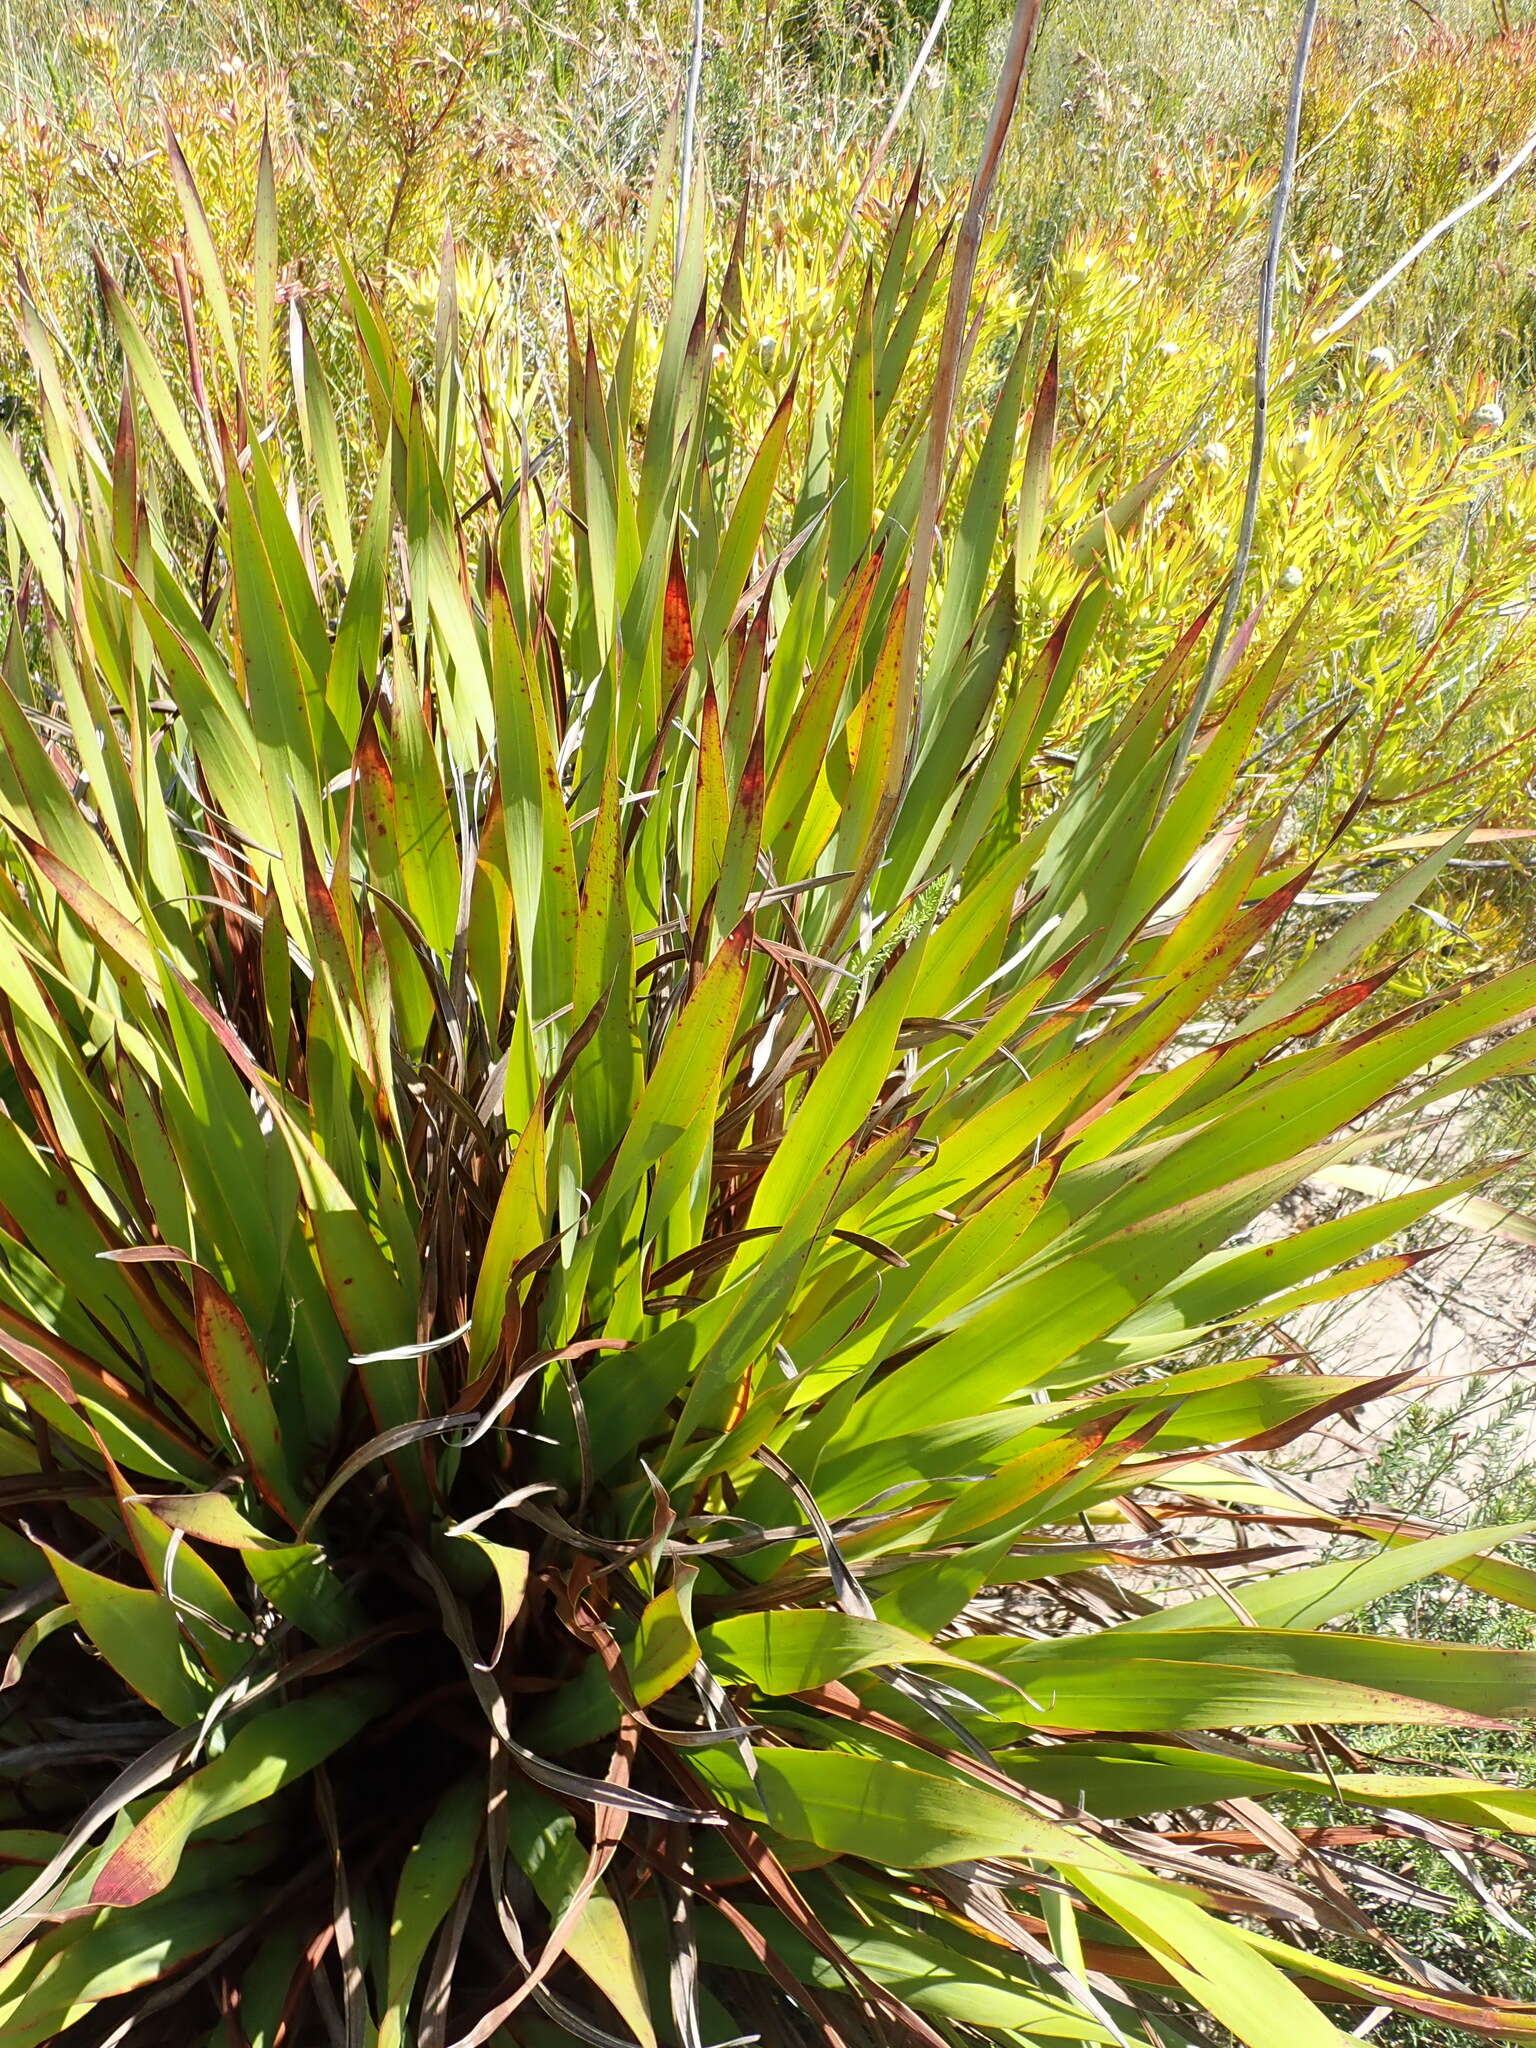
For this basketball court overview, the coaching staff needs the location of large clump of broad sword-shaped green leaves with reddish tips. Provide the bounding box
[0,140,1536,2048]
